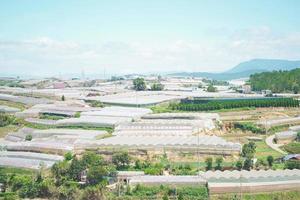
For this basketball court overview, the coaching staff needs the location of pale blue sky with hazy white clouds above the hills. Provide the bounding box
[0,0,300,76]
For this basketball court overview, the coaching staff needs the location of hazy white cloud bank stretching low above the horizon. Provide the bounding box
[0,27,300,75]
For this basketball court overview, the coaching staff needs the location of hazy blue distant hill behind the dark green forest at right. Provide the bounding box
[169,59,300,80]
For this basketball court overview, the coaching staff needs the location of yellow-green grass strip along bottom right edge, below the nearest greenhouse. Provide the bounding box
[210,191,300,200]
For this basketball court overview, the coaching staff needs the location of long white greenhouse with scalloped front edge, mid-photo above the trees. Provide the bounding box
[76,135,241,155]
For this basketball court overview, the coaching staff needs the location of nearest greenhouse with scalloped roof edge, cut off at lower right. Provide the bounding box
[199,169,300,193]
